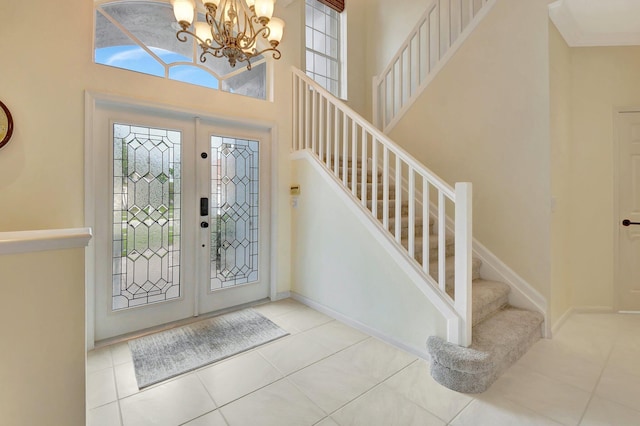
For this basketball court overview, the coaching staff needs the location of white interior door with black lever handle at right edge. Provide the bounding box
[616,112,640,311]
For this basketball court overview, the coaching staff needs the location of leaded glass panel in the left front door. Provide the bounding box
[112,124,181,310]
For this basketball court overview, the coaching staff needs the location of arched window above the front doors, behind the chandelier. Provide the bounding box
[94,1,267,99]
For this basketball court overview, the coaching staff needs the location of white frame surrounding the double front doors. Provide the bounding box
[84,91,279,350]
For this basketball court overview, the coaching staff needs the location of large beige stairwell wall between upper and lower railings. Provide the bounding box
[376,0,551,300]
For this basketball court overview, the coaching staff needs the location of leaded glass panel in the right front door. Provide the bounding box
[210,136,260,290]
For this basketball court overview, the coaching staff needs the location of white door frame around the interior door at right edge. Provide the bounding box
[612,107,640,311]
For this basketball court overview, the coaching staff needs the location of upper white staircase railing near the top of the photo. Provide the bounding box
[373,0,496,133]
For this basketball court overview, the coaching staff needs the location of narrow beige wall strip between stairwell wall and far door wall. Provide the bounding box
[549,22,573,324]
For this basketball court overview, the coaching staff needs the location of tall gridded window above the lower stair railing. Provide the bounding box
[305,0,346,98]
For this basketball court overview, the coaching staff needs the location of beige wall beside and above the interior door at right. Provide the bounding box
[570,46,640,308]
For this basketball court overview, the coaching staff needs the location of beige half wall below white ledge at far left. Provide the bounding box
[0,249,85,426]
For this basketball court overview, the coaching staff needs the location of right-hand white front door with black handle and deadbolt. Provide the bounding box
[197,121,270,312]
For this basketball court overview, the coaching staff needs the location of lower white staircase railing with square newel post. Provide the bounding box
[292,68,472,346]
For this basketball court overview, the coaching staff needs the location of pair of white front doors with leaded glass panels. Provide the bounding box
[93,99,270,341]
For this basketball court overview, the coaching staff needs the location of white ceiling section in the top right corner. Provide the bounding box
[549,0,640,46]
